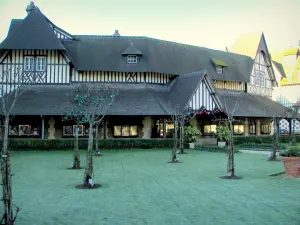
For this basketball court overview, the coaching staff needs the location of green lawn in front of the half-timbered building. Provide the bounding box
[0,150,300,225]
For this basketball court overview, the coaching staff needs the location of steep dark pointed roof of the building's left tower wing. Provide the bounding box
[0,8,65,50]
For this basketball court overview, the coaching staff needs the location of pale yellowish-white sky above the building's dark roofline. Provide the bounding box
[0,0,300,51]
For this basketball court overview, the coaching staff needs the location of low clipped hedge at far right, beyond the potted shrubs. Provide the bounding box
[234,135,300,145]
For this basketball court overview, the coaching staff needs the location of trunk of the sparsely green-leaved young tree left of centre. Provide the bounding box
[83,119,94,186]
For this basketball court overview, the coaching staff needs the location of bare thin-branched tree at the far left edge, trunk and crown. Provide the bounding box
[0,68,27,225]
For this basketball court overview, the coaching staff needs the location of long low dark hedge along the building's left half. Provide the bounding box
[0,138,174,150]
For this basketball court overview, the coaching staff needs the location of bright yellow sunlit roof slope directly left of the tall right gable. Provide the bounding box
[230,33,263,59]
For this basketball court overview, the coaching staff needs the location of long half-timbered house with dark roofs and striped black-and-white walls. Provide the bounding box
[0,4,287,139]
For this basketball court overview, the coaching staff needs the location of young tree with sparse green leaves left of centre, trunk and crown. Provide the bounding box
[75,84,117,187]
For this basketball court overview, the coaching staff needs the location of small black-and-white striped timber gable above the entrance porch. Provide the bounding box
[188,77,221,111]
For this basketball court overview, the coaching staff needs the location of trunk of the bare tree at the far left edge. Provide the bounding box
[1,115,14,225]
